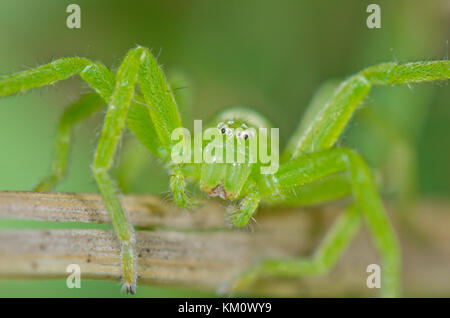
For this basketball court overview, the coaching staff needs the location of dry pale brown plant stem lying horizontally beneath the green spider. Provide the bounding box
[0,192,450,296]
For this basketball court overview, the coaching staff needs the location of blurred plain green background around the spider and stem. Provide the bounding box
[0,0,450,297]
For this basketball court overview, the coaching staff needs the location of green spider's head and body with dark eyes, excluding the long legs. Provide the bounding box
[184,112,279,227]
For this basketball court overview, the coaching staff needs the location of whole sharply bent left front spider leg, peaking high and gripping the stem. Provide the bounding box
[92,47,189,293]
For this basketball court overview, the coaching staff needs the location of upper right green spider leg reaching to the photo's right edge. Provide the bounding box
[282,60,450,162]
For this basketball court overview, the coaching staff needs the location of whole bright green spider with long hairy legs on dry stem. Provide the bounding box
[0,47,450,296]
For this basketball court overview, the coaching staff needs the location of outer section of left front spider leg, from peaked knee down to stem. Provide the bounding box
[92,48,146,293]
